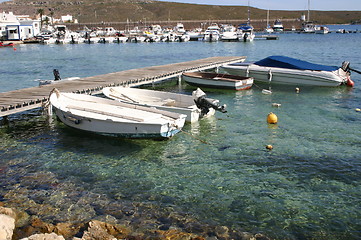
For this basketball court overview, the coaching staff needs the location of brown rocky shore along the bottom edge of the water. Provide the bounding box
[0,202,269,240]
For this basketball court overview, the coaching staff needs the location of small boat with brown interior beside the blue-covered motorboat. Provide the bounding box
[182,72,253,90]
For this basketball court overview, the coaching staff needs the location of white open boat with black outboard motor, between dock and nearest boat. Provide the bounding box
[103,87,225,122]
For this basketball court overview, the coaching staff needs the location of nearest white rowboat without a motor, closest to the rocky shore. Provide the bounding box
[49,89,186,139]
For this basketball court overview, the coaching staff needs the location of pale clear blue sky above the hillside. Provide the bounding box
[159,0,361,11]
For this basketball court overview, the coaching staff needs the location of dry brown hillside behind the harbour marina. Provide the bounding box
[0,0,361,24]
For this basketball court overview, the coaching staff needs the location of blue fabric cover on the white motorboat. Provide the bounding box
[254,56,339,72]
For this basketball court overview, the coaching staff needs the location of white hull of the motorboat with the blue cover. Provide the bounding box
[220,63,346,87]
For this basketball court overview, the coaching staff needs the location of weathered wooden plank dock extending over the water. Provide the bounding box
[0,56,246,117]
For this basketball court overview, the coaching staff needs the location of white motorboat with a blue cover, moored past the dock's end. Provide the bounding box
[220,56,353,86]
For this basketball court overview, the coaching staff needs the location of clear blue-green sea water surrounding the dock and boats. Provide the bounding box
[0,25,361,240]
